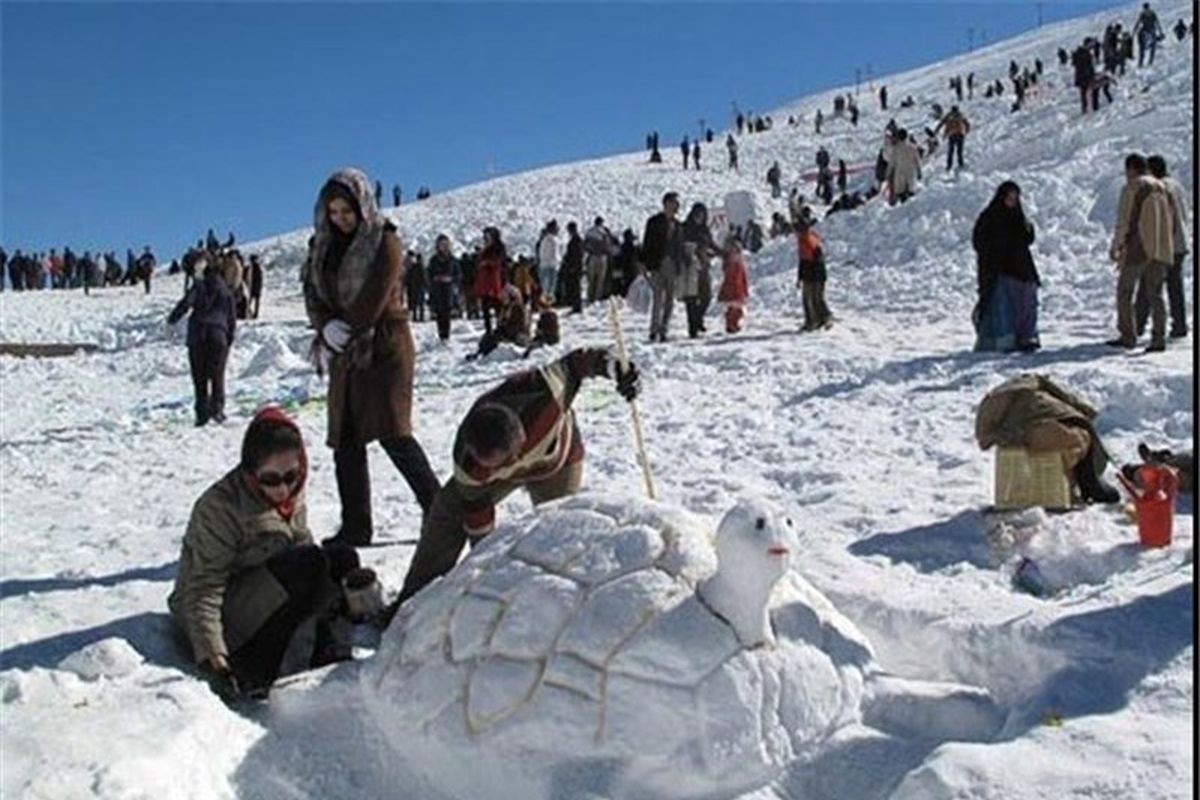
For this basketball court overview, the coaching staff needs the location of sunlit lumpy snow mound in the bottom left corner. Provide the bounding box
[0,657,264,800]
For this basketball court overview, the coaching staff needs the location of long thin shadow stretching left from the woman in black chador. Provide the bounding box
[784,343,1114,407]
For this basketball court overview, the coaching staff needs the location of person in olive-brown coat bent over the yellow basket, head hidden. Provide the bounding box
[976,374,1120,503]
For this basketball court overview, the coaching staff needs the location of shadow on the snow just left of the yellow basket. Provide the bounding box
[848,511,991,573]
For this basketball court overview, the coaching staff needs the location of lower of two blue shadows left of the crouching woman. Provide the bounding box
[0,612,192,670]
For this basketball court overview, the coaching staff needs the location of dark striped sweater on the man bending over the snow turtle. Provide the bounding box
[452,348,608,536]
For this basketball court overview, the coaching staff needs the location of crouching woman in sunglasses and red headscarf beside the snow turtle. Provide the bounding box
[167,407,379,699]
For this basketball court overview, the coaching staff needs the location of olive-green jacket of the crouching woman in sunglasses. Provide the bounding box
[167,467,312,663]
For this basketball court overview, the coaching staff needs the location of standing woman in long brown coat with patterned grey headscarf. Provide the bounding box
[304,169,438,546]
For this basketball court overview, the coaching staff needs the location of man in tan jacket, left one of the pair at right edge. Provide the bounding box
[1108,154,1175,353]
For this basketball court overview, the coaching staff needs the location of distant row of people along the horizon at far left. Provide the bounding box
[0,245,158,294]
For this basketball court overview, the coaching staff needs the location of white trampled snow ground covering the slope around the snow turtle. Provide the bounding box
[0,1,1195,800]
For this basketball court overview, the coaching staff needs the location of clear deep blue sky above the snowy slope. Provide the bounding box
[0,0,1121,260]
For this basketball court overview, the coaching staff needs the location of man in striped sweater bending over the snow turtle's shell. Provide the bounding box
[389,348,638,613]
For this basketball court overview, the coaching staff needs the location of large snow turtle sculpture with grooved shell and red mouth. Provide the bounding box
[361,495,992,800]
